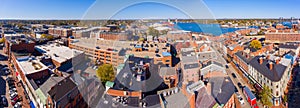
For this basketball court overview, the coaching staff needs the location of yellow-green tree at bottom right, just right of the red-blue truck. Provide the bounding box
[259,86,272,107]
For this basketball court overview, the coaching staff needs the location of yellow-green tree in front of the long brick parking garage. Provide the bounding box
[96,64,115,85]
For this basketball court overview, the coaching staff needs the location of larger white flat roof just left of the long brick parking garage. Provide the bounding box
[35,43,83,63]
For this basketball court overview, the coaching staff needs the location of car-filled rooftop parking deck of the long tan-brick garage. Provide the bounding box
[71,38,171,58]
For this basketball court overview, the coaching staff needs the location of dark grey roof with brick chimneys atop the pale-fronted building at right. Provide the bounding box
[249,56,287,82]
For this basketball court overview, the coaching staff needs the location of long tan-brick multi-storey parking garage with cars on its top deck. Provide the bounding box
[69,38,172,66]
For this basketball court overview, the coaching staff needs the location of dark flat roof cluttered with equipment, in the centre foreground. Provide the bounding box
[113,56,165,91]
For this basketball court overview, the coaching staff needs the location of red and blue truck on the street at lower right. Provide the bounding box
[243,86,258,108]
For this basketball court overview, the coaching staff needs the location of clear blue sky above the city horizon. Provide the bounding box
[0,0,300,19]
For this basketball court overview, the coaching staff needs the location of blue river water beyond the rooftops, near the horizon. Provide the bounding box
[174,23,245,36]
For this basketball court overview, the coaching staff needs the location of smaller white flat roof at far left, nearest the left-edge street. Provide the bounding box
[17,57,48,75]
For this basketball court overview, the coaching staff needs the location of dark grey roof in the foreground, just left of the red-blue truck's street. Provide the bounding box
[209,76,234,105]
